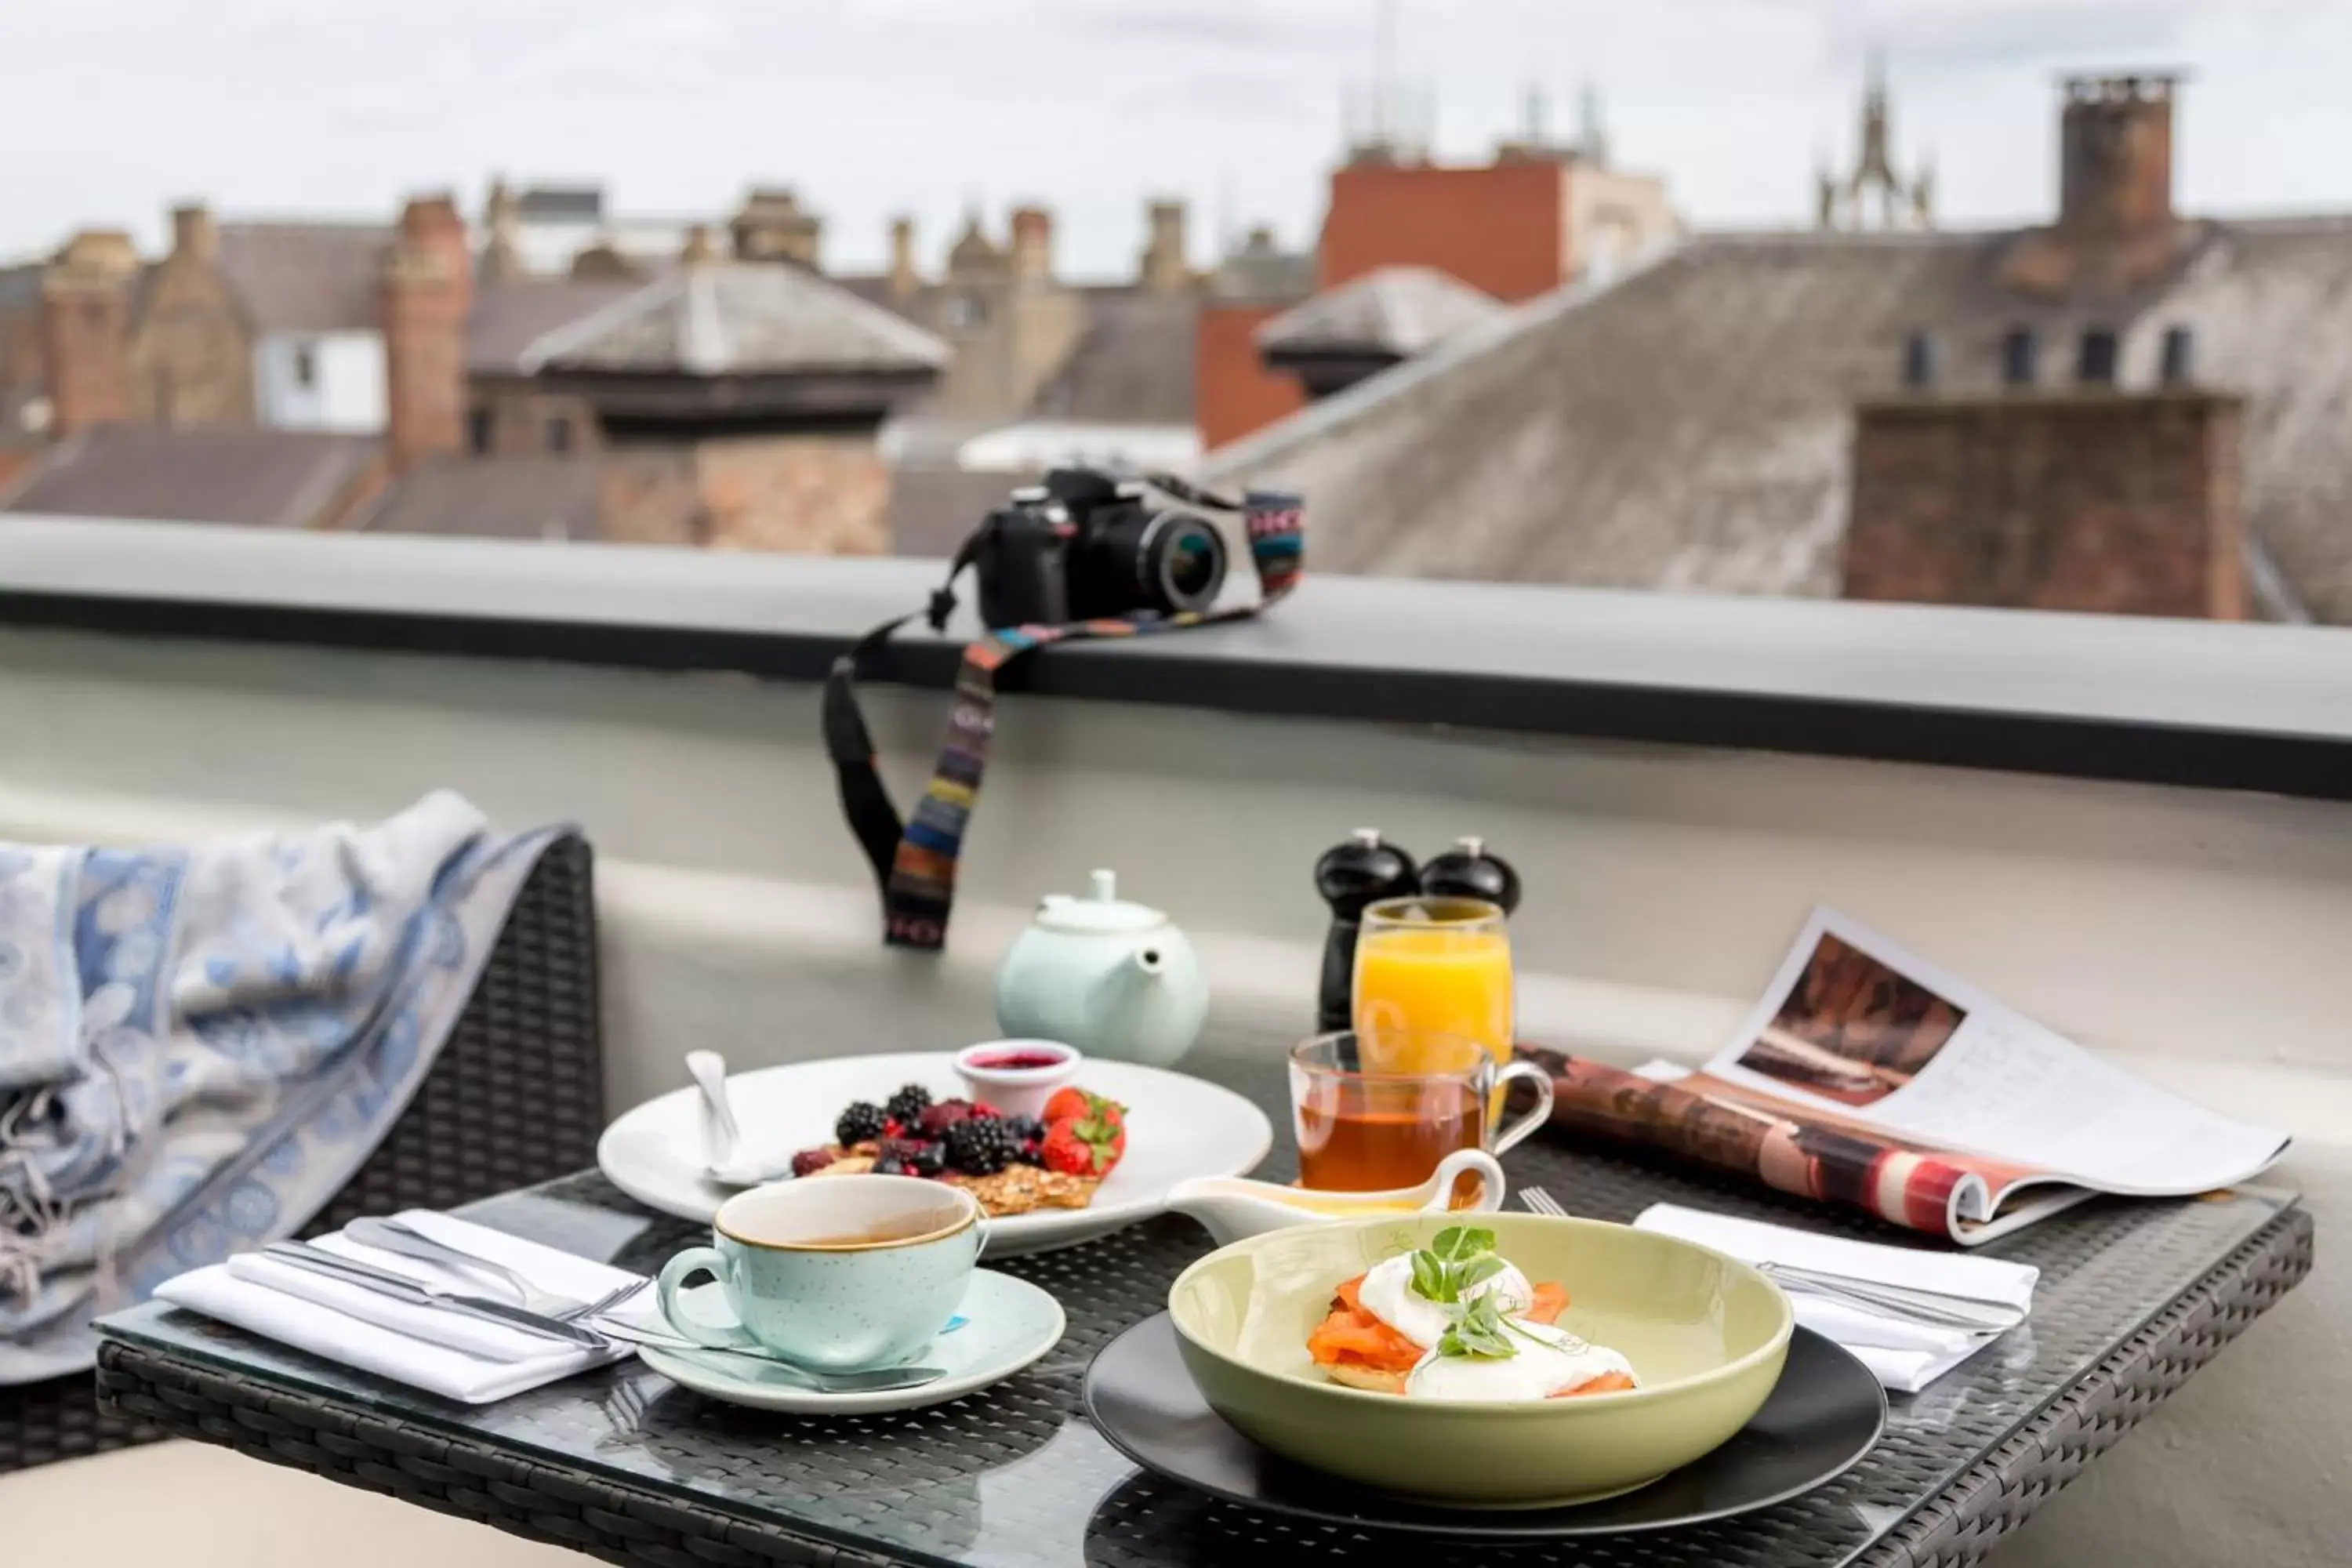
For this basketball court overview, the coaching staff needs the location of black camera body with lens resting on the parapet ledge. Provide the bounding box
[964,468,1225,628]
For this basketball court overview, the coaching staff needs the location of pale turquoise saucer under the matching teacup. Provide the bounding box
[637,1269,1065,1415]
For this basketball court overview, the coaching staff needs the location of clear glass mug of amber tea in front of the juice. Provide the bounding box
[1291,1029,1552,1192]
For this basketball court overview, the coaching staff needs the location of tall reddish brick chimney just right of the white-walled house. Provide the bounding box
[383,195,473,473]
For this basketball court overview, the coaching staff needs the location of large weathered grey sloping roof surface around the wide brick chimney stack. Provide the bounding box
[1204,219,2352,623]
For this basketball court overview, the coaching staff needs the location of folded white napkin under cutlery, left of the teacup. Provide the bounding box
[155,1208,637,1406]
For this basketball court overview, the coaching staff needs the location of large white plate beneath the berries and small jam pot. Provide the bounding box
[595,1051,1275,1258]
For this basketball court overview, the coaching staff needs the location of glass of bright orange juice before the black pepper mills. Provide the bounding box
[1352,895,1515,1072]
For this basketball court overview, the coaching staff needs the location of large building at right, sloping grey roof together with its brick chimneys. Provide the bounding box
[1209,78,2352,623]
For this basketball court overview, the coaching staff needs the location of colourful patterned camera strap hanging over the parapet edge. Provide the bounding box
[823,475,1305,952]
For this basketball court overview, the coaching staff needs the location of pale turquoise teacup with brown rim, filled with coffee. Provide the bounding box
[656,1175,981,1373]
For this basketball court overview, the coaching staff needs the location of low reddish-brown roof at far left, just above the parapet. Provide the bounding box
[0,426,376,529]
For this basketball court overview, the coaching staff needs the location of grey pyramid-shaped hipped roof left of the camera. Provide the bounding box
[520,261,950,376]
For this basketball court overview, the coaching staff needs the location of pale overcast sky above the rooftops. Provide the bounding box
[0,0,2352,275]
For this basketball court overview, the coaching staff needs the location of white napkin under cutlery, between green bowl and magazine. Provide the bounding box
[1635,1203,2042,1394]
